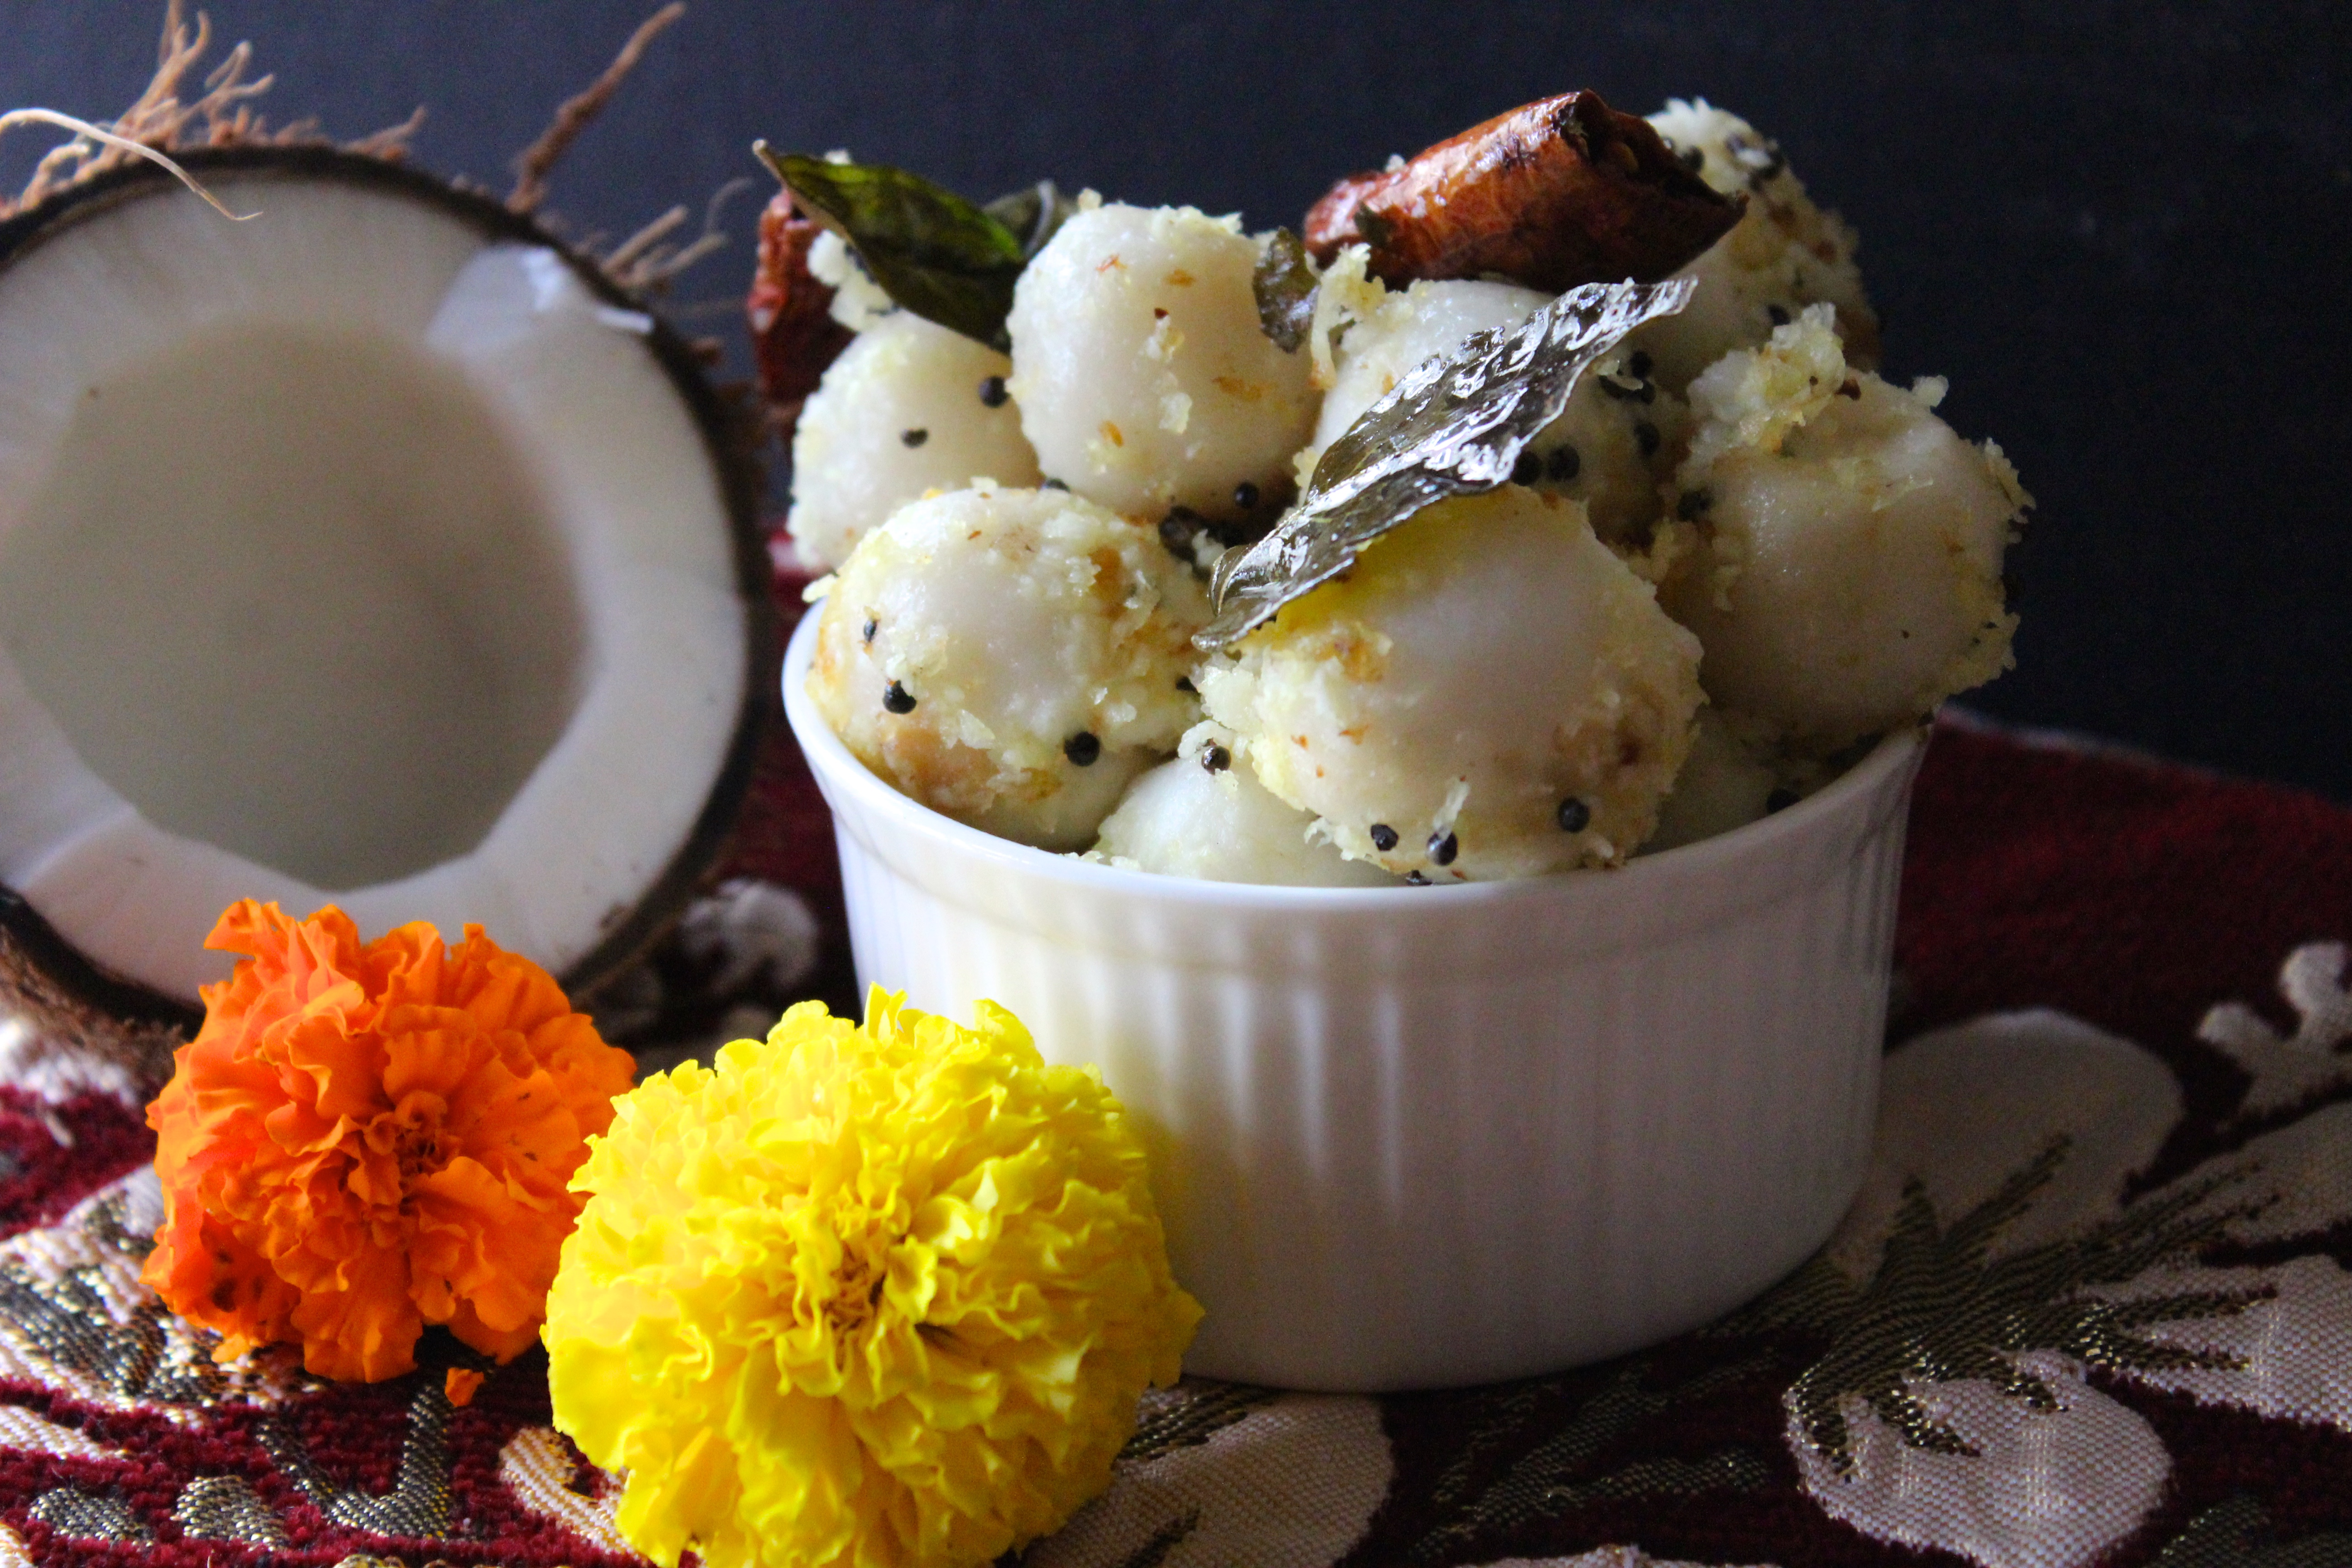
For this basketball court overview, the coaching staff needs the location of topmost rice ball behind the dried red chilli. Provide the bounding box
[1630,99,1879,392]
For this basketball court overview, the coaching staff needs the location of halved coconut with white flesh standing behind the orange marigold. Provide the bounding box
[0,148,774,1072]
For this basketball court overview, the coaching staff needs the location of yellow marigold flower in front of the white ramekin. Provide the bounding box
[544,990,1200,1568]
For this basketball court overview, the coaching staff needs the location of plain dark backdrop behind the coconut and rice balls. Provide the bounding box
[0,0,2352,799]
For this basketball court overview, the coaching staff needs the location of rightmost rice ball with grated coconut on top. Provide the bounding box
[1665,306,2032,752]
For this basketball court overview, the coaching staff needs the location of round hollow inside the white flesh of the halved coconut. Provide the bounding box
[0,320,581,889]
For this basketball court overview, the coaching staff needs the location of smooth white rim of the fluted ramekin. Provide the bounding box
[781,597,1933,915]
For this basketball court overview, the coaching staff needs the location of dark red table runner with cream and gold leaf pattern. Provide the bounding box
[0,701,2352,1568]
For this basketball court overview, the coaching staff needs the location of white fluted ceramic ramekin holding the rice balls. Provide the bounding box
[783,611,1924,1392]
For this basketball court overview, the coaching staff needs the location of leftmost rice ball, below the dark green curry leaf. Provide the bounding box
[785,310,1039,569]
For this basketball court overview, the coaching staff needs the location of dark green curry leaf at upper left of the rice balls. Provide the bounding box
[753,141,1030,350]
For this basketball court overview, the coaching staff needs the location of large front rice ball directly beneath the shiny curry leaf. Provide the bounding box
[1195,484,1700,882]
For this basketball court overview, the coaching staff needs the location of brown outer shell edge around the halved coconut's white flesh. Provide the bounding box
[0,143,781,1081]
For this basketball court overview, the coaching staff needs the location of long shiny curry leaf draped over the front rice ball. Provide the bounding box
[1192,277,1696,653]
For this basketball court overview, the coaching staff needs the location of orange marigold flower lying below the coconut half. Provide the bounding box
[143,898,635,1382]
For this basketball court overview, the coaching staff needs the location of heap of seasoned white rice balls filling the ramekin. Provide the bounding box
[788,101,2030,886]
